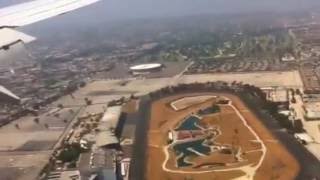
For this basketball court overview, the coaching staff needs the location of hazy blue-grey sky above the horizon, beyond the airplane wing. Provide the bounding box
[0,0,320,41]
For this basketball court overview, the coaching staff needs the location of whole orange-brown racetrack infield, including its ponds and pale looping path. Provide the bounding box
[145,93,300,180]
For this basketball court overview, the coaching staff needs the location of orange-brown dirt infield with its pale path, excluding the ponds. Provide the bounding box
[146,93,300,180]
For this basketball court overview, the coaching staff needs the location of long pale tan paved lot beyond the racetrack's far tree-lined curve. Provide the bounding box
[60,71,303,106]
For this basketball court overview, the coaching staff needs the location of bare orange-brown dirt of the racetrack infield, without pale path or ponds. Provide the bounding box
[146,93,300,180]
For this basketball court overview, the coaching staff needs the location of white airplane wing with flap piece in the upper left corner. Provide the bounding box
[0,0,100,50]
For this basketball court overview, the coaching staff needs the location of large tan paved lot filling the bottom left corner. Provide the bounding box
[0,107,79,180]
